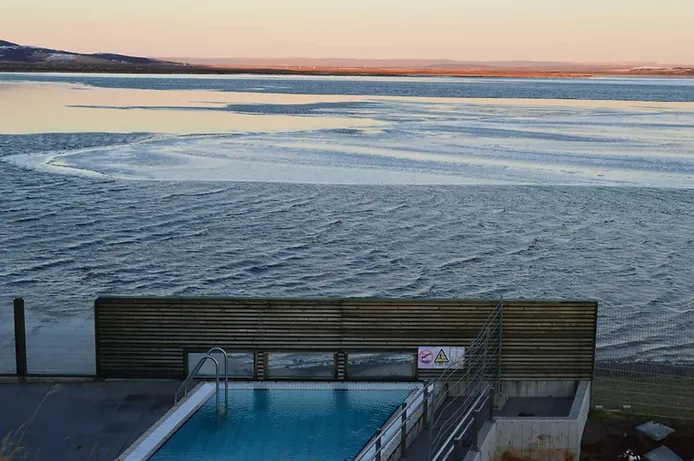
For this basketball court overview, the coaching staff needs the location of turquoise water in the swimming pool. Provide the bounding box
[151,389,411,461]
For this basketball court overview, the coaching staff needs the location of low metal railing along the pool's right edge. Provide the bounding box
[353,383,433,461]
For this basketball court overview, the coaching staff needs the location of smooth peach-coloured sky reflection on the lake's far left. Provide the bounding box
[0,83,384,134]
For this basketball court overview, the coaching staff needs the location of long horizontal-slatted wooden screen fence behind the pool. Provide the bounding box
[94,297,597,380]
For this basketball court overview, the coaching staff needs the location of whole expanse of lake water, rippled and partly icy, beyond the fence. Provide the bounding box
[0,75,694,372]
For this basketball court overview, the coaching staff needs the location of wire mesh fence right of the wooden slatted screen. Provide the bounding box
[592,309,694,420]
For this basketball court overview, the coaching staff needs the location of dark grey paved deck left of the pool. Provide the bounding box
[0,381,180,461]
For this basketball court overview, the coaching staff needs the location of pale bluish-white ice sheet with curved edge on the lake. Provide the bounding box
[7,99,694,188]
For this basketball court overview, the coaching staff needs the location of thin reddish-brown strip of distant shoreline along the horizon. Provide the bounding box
[0,62,694,79]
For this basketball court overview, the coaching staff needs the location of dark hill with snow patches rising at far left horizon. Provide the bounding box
[0,40,175,66]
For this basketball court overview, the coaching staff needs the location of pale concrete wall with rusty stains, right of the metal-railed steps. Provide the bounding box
[465,381,590,461]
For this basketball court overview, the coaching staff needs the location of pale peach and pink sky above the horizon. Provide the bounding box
[0,0,694,65]
